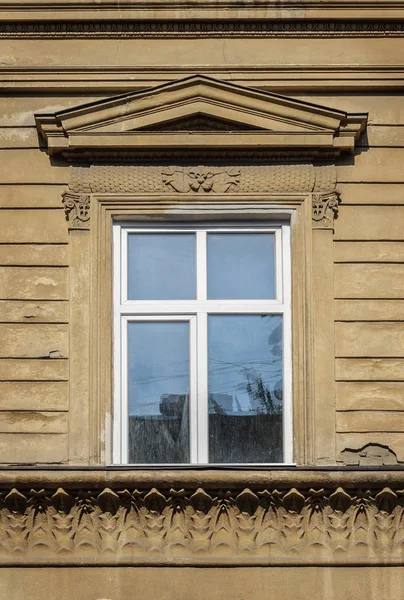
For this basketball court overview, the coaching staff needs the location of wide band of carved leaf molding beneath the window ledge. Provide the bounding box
[0,473,404,566]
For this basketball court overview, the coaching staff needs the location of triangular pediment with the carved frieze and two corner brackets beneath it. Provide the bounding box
[36,75,367,229]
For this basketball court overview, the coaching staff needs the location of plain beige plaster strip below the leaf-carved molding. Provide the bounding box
[0,567,404,600]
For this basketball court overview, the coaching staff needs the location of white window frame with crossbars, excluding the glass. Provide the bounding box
[112,221,293,468]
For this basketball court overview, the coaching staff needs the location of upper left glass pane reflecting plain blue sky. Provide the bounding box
[128,233,196,300]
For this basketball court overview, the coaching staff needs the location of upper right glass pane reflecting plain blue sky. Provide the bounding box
[208,233,275,299]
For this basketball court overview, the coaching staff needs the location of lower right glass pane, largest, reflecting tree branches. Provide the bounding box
[208,315,283,463]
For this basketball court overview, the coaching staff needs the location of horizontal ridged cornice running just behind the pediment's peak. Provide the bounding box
[4,64,404,93]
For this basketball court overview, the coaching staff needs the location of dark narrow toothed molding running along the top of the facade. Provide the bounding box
[0,19,404,39]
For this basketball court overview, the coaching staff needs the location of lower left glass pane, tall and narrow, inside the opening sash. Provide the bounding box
[128,321,189,464]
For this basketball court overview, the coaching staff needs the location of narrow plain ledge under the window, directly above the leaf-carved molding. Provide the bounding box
[0,465,404,490]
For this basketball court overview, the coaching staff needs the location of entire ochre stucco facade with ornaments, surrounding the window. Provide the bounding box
[0,0,404,600]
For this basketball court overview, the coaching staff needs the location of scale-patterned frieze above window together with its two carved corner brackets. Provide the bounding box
[62,165,339,229]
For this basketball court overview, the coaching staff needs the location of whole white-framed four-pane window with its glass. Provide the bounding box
[113,223,292,465]
